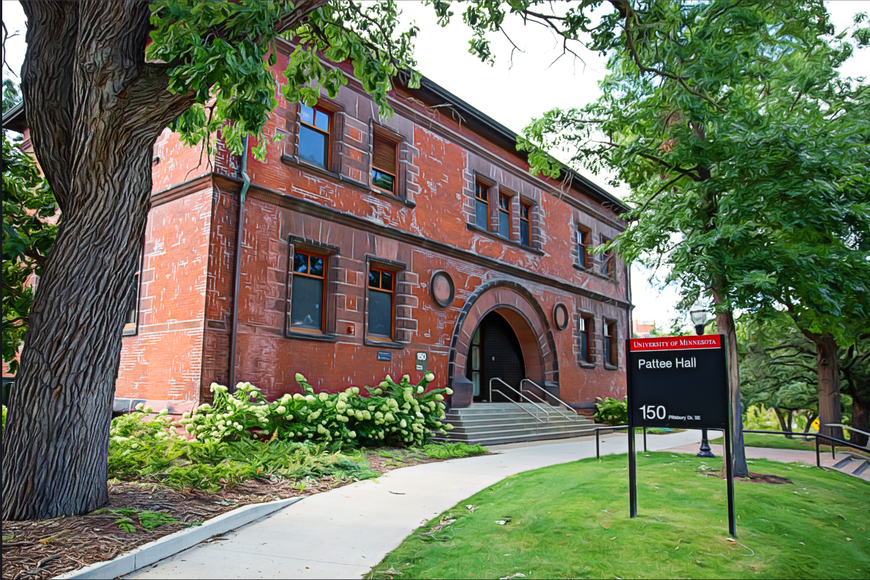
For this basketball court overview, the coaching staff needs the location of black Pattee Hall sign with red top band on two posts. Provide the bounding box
[625,334,737,537]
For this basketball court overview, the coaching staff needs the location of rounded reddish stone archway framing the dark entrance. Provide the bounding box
[447,281,559,402]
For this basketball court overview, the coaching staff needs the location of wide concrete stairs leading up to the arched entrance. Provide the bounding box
[433,403,595,445]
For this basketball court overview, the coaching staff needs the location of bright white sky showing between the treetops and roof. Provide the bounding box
[2,0,870,328]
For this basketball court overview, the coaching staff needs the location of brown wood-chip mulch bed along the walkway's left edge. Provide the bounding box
[3,454,441,579]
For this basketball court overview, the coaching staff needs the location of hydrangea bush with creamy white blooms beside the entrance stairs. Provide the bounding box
[181,373,453,446]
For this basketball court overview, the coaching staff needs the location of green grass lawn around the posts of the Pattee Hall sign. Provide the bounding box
[370,452,870,578]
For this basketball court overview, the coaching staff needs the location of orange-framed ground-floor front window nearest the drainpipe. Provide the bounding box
[290,251,328,332]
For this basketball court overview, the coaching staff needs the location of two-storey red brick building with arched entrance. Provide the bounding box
[6,44,630,412]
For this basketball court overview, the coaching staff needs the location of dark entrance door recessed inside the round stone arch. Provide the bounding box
[466,312,525,402]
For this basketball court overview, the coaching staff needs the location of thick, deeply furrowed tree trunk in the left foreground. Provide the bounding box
[3,1,189,519]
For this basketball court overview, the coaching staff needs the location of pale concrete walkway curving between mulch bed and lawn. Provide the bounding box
[127,431,700,580]
